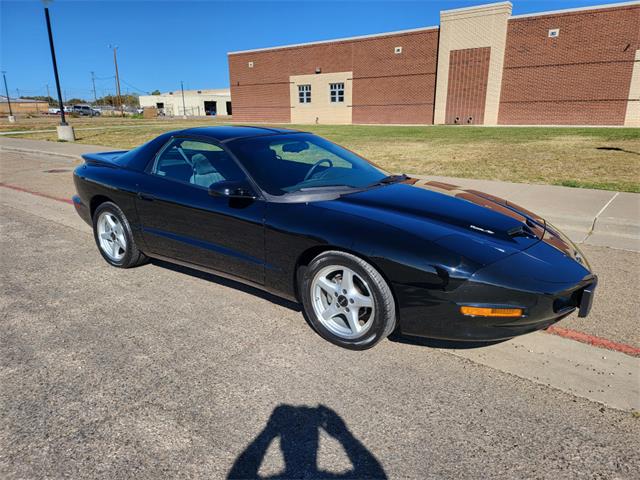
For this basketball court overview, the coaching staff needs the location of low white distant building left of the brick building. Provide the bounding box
[140,88,231,117]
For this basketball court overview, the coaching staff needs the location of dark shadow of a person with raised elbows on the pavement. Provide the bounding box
[227,404,387,480]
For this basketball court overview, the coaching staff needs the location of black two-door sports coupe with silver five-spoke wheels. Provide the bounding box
[73,126,597,349]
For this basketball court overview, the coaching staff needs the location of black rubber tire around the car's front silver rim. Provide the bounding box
[298,250,396,350]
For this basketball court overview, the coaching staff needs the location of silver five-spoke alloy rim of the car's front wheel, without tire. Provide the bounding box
[311,265,375,339]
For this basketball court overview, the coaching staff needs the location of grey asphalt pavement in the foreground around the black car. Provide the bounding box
[0,148,640,479]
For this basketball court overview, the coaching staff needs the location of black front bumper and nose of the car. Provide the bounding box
[394,234,598,341]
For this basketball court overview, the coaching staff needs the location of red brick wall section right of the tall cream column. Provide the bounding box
[498,5,640,125]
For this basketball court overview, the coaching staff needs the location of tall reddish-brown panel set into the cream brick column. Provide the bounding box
[445,47,491,125]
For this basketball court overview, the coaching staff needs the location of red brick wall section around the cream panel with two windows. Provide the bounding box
[229,30,438,123]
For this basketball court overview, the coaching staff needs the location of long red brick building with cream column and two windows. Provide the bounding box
[228,1,640,126]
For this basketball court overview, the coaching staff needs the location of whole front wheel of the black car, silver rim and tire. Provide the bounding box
[299,251,396,350]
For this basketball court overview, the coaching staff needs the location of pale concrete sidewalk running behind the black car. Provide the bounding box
[0,138,640,252]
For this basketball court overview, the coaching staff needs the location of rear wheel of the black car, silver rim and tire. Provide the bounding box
[93,202,147,268]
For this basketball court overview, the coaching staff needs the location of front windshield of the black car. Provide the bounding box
[228,133,387,195]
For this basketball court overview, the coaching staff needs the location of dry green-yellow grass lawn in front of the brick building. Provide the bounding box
[5,118,640,192]
